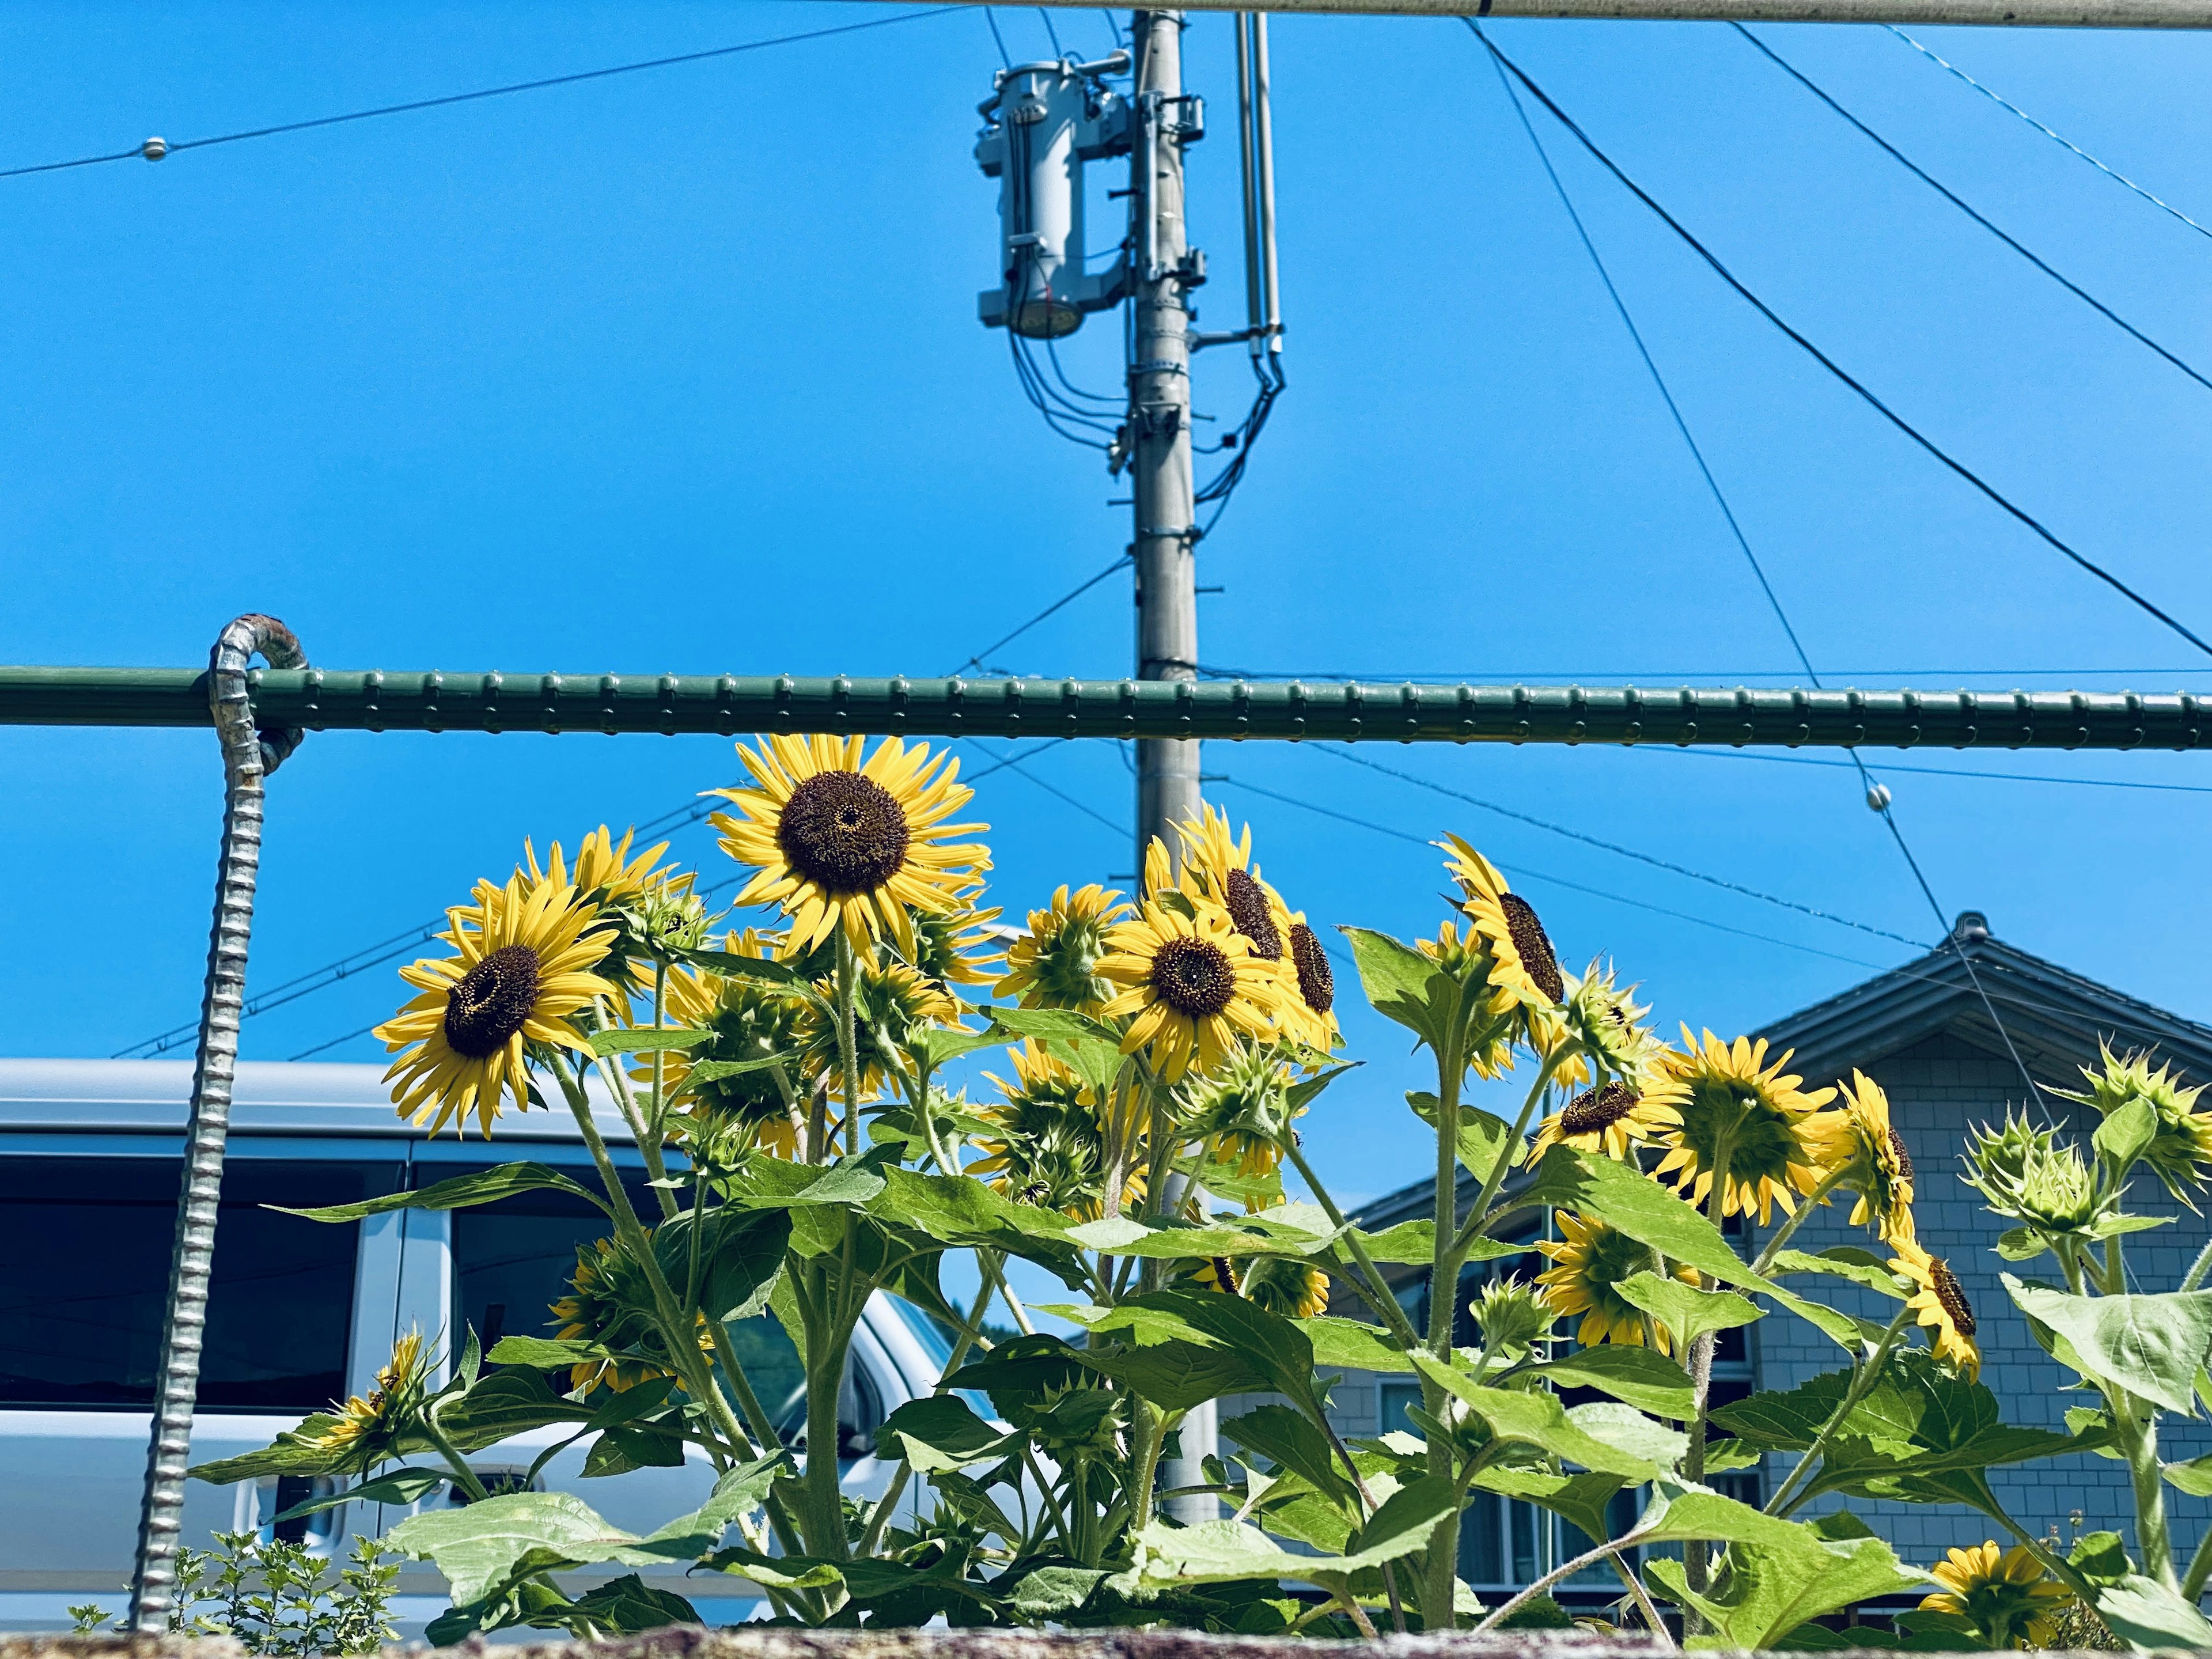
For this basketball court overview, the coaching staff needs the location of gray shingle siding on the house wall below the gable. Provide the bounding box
[1752,1031,2212,1564]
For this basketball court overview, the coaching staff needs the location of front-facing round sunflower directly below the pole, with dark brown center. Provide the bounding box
[1097,900,1283,1084]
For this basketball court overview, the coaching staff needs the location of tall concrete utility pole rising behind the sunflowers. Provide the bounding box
[1128,11,1206,874]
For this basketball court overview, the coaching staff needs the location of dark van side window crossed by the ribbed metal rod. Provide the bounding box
[0,1154,403,1411]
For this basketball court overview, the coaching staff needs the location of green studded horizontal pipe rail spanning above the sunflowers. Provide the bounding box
[0,666,2212,750]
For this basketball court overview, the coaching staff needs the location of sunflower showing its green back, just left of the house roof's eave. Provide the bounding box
[1648,1027,1836,1225]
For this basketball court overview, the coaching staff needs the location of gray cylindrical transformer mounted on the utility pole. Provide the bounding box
[975,51,1135,340]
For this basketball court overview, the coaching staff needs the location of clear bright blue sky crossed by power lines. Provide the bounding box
[0,0,2212,1221]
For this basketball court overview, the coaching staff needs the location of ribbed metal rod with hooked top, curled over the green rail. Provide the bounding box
[131,615,308,1635]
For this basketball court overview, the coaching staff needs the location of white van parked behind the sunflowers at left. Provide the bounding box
[0,1059,949,1635]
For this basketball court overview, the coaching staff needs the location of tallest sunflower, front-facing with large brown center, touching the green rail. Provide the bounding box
[710,732,991,956]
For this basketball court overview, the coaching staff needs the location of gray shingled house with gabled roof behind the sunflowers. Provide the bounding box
[1309,911,2212,1599]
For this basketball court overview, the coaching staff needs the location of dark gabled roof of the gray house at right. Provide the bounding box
[1759,909,2212,1088]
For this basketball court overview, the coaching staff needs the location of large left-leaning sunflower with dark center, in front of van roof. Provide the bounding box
[376,872,619,1135]
